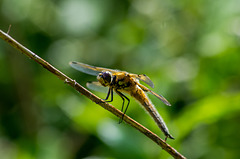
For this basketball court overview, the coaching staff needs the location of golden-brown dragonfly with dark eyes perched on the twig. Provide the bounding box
[69,61,174,141]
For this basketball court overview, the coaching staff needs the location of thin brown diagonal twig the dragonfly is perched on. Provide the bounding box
[0,30,185,159]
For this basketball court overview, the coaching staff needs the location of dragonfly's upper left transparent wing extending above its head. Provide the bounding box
[69,61,118,76]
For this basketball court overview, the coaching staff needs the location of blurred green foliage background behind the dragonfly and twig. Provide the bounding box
[0,0,240,159]
